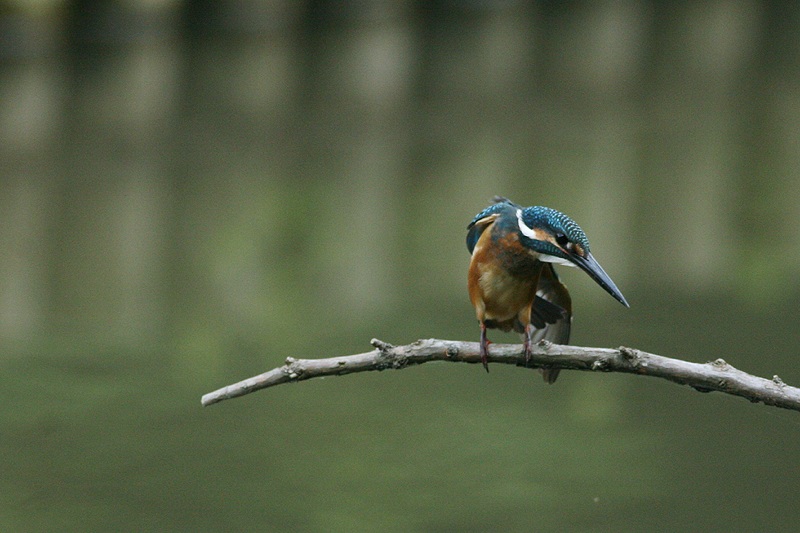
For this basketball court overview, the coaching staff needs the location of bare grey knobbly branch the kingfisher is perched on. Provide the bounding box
[202,339,800,411]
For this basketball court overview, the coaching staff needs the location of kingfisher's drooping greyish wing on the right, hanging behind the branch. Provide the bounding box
[531,263,572,383]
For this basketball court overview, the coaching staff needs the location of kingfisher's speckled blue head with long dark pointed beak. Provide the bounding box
[515,206,630,307]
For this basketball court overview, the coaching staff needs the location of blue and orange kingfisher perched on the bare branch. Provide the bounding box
[467,196,630,383]
